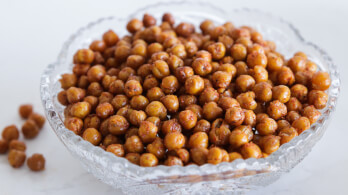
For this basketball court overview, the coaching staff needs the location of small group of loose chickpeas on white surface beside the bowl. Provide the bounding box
[0,104,46,171]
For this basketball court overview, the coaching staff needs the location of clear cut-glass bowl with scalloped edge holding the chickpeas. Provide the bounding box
[41,1,340,194]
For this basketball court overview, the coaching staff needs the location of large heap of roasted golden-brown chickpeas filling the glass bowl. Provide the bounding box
[58,13,331,167]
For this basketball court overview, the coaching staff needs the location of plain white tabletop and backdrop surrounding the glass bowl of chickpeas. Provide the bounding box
[0,0,348,195]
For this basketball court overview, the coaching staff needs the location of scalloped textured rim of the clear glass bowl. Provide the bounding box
[40,1,341,178]
